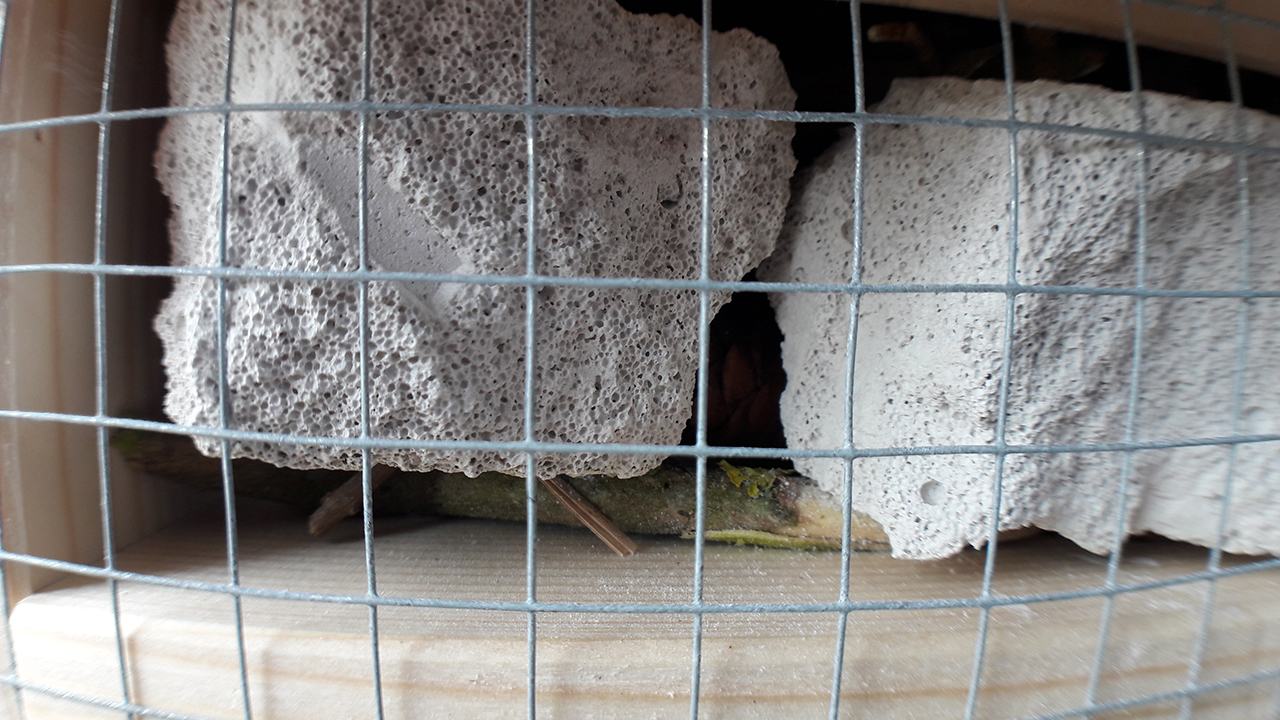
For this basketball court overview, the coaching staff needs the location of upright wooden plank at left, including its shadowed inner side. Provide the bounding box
[0,0,189,601]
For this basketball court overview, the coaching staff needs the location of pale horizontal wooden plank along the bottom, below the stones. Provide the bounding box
[13,507,1280,720]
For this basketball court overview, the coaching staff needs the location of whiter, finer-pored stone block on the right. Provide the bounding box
[762,78,1280,557]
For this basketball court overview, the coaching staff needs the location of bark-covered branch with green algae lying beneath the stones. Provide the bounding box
[111,430,888,550]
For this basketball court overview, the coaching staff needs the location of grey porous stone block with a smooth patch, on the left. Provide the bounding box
[156,0,795,477]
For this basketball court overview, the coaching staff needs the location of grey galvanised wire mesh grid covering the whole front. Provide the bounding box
[0,0,1280,720]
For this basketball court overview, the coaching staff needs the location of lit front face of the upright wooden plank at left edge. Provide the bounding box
[0,1,106,607]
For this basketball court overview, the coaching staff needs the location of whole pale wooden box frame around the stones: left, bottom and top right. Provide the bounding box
[0,0,1280,720]
